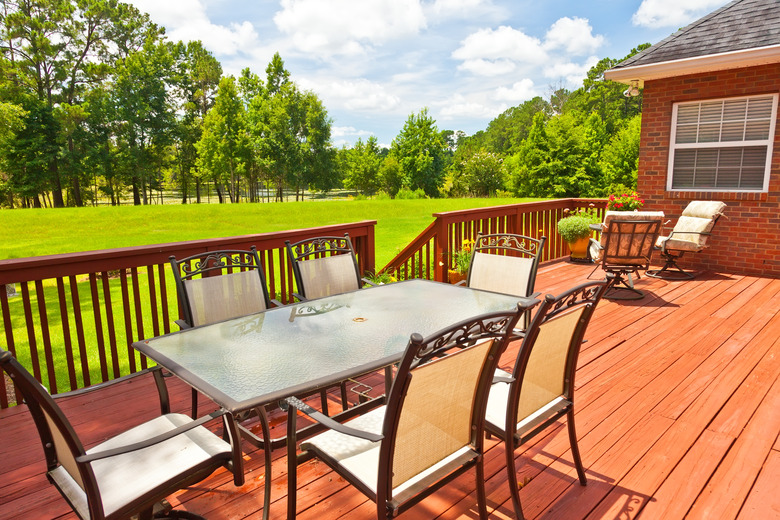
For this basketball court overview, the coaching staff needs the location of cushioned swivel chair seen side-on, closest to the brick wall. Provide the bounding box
[647,200,726,280]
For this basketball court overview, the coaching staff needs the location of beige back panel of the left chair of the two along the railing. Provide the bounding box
[184,269,266,327]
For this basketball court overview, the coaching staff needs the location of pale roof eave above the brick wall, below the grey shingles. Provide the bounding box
[604,45,780,87]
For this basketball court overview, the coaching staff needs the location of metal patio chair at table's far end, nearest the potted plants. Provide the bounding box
[466,233,547,327]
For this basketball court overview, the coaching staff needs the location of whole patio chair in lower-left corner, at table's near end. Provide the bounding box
[0,349,244,520]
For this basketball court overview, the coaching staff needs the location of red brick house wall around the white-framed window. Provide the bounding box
[637,64,780,277]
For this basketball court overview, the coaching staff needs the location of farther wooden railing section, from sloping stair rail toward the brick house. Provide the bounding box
[380,199,606,281]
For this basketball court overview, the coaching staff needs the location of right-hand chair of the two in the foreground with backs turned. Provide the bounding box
[485,275,612,519]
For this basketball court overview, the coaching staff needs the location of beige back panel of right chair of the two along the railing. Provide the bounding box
[298,254,360,299]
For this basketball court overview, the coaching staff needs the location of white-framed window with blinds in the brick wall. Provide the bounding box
[667,94,778,191]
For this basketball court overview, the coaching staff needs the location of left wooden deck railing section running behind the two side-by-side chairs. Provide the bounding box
[0,220,376,408]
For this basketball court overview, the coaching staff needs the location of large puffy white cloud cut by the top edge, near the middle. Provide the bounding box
[274,0,426,58]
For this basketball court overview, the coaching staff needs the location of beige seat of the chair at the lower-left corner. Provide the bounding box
[51,414,231,518]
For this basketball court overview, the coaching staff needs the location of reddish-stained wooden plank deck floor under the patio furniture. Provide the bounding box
[0,263,780,520]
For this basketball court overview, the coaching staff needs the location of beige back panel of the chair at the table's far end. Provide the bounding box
[469,253,534,296]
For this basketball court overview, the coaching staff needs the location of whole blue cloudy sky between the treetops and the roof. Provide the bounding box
[129,0,727,146]
